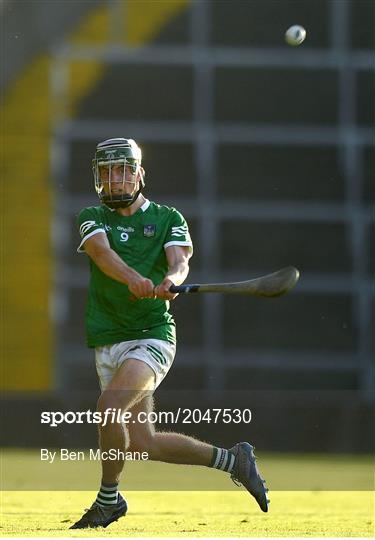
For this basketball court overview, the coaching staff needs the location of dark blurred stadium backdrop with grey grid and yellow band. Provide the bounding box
[1,0,375,458]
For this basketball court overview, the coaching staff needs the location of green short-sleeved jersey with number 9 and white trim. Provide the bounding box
[77,200,193,347]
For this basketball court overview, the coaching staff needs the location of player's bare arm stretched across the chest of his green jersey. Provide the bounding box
[84,233,154,298]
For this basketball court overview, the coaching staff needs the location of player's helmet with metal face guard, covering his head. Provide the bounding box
[92,138,145,208]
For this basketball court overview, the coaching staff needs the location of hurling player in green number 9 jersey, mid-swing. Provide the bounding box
[71,138,268,529]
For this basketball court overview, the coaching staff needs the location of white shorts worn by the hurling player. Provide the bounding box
[95,339,176,390]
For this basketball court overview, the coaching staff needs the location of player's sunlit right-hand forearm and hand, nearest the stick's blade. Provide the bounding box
[155,246,191,300]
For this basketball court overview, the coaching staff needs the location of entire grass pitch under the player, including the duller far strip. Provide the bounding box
[0,450,375,538]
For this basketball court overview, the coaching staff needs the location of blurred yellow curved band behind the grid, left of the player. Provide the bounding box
[0,0,188,391]
